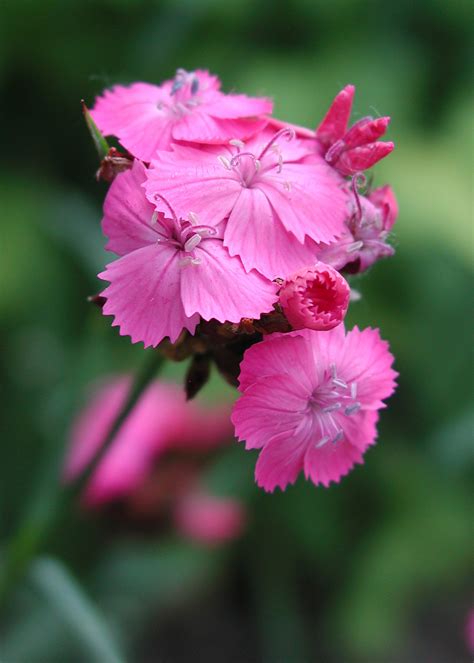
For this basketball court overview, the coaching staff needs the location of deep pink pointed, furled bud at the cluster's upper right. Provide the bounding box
[316,85,394,175]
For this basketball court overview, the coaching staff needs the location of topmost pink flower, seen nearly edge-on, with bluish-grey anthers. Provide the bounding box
[91,69,272,161]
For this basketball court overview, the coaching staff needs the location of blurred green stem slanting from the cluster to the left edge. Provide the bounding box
[0,351,164,606]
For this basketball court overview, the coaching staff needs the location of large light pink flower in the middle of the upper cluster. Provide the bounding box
[146,129,347,278]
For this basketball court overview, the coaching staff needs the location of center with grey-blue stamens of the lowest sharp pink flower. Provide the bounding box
[308,364,361,449]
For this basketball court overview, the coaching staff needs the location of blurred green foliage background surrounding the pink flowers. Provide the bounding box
[0,0,474,663]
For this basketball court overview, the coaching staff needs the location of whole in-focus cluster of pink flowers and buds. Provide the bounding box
[87,69,397,490]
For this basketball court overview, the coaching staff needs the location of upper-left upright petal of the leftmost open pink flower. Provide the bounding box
[102,161,158,255]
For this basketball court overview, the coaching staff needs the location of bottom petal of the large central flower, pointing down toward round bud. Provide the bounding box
[224,188,317,279]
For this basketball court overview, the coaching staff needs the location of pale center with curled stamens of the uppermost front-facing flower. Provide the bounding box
[218,127,295,189]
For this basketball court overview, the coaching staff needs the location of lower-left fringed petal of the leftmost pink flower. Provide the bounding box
[99,244,199,347]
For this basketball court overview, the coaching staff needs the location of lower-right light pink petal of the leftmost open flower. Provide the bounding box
[181,239,278,322]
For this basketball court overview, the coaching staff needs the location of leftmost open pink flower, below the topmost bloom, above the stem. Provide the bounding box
[99,162,277,347]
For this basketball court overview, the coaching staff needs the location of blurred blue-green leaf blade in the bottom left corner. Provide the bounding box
[30,557,125,663]
